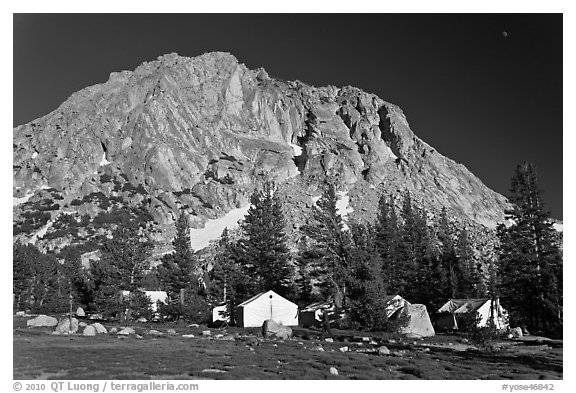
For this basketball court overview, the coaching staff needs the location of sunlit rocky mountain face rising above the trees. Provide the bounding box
[13,53,507,254]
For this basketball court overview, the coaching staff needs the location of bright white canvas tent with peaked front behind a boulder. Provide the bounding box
[236,291,298,327]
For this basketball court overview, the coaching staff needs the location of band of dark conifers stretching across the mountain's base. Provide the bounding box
[13,164,562,329]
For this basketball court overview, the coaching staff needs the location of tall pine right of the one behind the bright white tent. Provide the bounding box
[302,184,350,307]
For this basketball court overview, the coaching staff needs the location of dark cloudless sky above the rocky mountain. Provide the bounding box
[13,14,563,219]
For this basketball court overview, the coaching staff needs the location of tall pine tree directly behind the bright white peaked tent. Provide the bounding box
[238,183,294,296]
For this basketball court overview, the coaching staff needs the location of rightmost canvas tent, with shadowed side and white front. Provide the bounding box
[436,298,508,330]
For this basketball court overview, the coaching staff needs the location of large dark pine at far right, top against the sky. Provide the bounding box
[498,163,563,329]
